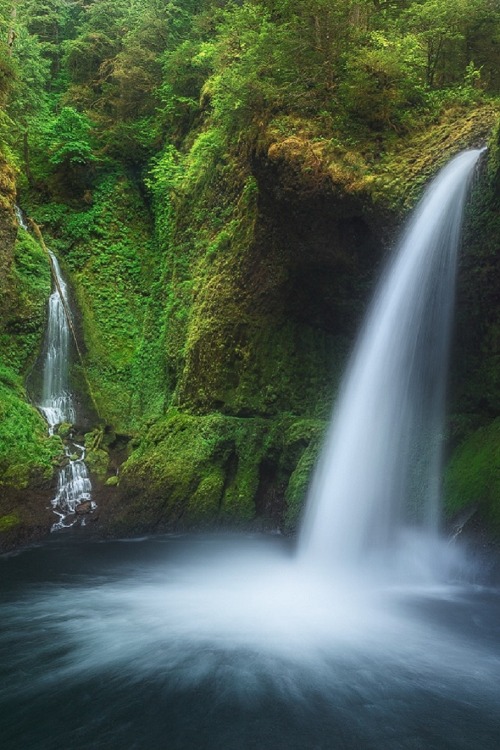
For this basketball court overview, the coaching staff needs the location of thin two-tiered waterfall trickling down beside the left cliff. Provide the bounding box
[40,247,97,531]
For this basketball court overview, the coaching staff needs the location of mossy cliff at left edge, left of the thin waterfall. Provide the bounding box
[0,154,61,549]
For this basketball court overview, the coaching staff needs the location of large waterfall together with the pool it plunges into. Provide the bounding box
[0,152,500,750]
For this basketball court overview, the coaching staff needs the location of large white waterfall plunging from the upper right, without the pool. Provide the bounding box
[300,150,481,568]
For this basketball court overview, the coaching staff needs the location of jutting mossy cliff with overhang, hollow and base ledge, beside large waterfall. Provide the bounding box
[115,107,496,540]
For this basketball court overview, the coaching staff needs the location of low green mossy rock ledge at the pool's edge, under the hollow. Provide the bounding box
[117,412,324,529]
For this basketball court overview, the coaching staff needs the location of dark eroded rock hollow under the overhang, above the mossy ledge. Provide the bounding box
[177,147,385,416]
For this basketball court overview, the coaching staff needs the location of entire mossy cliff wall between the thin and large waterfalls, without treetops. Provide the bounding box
[1,107,498,548]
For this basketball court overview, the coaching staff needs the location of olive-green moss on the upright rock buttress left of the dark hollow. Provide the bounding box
[152,129,346,424]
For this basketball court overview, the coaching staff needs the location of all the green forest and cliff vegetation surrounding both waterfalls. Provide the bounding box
[0,0,500,544]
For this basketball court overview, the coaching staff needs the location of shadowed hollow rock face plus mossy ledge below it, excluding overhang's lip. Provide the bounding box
[114,145,387,531]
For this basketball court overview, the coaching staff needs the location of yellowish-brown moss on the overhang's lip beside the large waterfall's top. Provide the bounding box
[263,102,499,214]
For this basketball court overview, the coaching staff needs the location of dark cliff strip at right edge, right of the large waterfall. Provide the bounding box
[445,126,500,535]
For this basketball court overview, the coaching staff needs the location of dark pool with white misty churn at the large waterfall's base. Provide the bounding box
[0,535,500,750]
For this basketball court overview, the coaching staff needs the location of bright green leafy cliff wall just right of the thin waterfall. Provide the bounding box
[27,169,165,431]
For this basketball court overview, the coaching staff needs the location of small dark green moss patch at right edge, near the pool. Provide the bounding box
[445,419,500,532]
